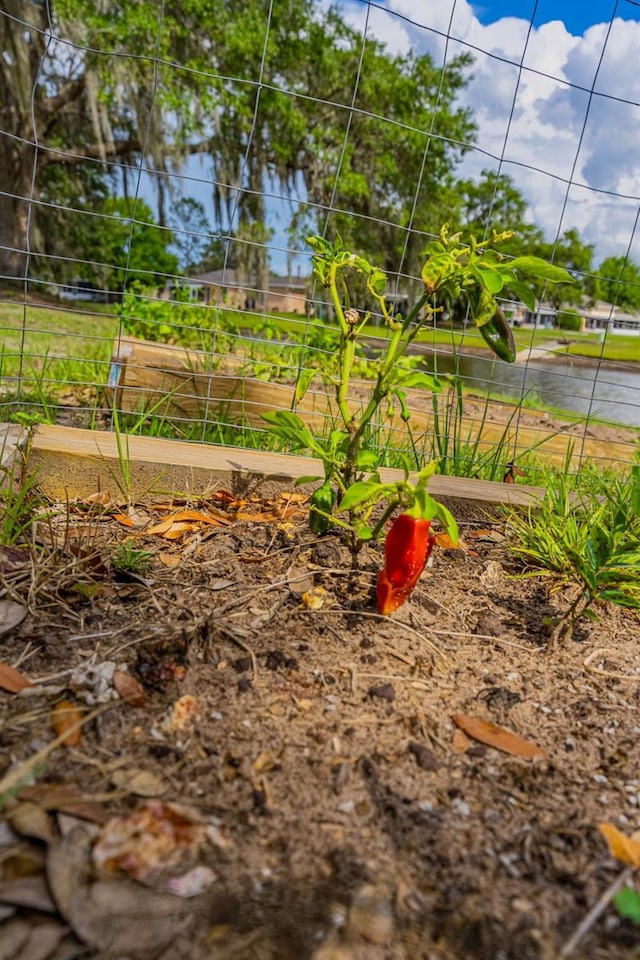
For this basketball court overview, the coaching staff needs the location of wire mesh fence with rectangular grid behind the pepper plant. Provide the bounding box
[0,0,640,479]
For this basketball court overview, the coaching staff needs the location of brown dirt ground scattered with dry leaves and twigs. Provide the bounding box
[0,491,640,960]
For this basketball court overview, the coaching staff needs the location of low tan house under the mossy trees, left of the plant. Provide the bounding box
[168,270,308,313]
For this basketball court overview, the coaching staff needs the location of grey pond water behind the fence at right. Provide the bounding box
[424,353,640,427]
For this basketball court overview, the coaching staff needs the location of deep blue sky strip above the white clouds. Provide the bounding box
[472,0,640,36]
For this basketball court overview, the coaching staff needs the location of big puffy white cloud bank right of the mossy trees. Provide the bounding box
[342,0,640,263]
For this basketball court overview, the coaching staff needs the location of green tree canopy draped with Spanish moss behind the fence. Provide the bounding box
[0,0,639,309]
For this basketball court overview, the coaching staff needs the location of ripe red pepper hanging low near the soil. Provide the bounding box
[378,513,435,615]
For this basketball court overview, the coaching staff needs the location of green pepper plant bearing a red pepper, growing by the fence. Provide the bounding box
[263,224,571,612]
